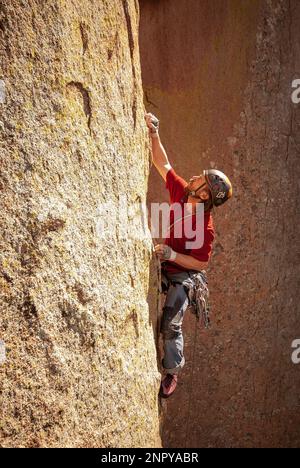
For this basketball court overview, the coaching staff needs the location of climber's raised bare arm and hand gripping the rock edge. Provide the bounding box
[145,113,172,180]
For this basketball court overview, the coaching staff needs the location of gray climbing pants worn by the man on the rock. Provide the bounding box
[160,270,196,374]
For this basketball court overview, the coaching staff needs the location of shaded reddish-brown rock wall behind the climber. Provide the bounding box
[140,0,300,447]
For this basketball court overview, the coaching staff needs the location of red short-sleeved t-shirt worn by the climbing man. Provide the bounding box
[164,168,215,273]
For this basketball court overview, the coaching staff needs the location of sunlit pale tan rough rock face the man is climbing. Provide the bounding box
[0,0,160,447]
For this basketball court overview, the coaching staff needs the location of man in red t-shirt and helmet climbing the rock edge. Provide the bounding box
[144,113,232,398]
